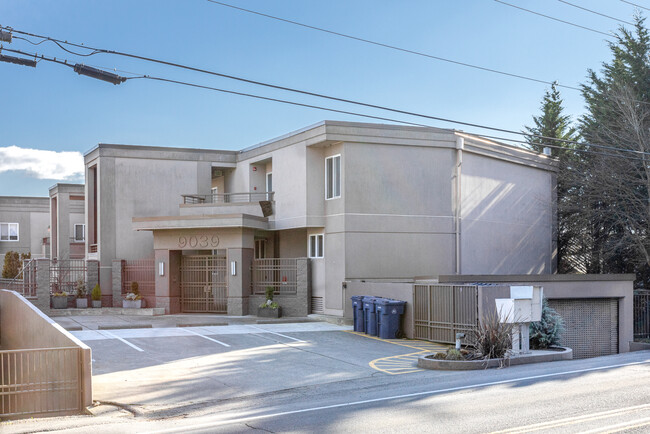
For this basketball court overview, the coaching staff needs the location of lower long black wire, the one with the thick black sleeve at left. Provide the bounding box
[2,48,650,161]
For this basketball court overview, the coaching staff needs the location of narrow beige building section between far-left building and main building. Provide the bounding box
[49,184,86,260]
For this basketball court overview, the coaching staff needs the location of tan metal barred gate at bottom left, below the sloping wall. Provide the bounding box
[0,348,83,417]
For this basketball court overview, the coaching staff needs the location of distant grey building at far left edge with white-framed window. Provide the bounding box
[0,196,50,269]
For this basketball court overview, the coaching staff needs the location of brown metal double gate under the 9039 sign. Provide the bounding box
[180,255,228,313]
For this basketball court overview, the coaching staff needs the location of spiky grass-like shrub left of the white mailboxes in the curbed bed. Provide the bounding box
[470,311,514,360]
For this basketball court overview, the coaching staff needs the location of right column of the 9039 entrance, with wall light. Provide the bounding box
[226,248,254,316]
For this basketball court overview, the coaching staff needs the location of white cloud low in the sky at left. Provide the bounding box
[0,146,84,181]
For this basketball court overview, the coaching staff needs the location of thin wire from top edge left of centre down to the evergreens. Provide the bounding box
[207,0,580,91]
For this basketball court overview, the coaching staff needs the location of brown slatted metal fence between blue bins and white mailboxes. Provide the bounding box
[413,285,479,343]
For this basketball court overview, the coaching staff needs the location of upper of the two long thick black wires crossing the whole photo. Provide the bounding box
[5,40,644,158]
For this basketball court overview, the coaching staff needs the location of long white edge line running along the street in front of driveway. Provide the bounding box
[149,359,650,434]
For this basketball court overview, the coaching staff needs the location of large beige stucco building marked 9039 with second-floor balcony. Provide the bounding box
[85,121,557,315]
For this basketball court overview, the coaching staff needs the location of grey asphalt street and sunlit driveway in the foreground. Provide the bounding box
[0,324,650,433]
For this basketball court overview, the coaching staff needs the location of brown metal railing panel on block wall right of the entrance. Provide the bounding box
[251,258,298,295]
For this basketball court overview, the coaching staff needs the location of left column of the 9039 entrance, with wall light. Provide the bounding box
[154,249,181,314]
